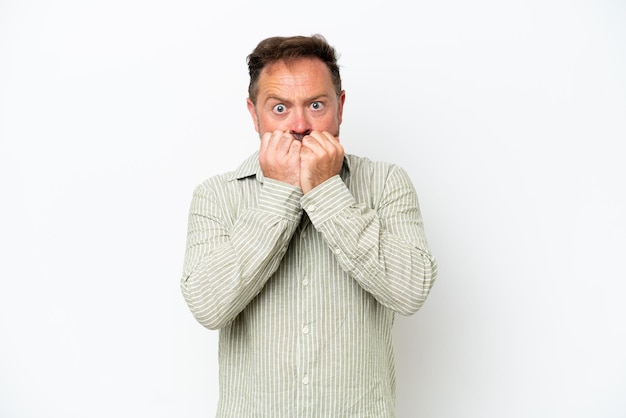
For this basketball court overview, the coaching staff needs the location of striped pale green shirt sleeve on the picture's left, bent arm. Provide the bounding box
[181,178,302,329]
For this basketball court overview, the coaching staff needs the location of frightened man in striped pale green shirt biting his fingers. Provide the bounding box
[181,35,437,418]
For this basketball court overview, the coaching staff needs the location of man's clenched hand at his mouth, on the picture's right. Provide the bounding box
[300,131,343,194]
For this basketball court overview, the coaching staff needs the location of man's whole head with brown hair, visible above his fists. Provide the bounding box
[248,35,345,139]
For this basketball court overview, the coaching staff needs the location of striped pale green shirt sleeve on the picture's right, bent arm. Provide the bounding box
[302,166,437,315]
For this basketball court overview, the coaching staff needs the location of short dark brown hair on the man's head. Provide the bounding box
[247,35,341,103]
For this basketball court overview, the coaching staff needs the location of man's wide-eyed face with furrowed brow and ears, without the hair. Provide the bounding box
[248,58,345,140]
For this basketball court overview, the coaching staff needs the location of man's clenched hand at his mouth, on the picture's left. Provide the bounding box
[259,131,302,187]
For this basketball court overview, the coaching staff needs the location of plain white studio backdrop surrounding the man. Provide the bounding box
[0,0,626,418]
